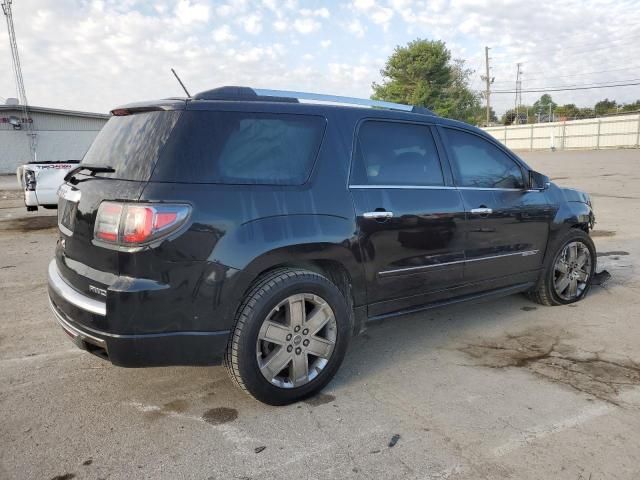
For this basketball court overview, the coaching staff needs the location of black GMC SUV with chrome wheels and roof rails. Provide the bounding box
[49,87,596,405]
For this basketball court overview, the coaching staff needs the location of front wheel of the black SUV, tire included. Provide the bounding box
[529,228,596,305]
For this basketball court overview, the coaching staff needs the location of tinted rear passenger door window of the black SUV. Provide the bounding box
[351,121,444,185]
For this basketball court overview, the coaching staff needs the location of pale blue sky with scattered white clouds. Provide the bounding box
[0,0,640,114]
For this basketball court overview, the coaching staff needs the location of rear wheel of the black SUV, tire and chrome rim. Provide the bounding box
[225,268,353,405]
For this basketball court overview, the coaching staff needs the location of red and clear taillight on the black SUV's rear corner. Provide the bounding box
[93,202,191,247]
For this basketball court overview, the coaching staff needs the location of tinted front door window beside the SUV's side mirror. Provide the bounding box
[443,128,524,188]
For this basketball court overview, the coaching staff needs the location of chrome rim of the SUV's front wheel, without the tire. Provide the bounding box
[553,242,591,300]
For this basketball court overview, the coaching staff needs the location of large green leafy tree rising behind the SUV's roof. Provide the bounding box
[372,39,480,123]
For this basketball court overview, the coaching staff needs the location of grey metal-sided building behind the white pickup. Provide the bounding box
[0,98,109,173]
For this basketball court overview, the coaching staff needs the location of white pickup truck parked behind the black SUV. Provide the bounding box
[16,160,80,212]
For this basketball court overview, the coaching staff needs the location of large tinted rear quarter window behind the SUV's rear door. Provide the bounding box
[153,111,325,185]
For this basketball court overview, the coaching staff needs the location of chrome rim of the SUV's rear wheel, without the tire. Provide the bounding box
[256,293,338,388]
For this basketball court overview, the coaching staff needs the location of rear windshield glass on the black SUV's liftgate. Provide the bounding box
[81,111,180,181]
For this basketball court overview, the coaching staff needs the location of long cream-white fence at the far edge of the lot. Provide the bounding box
[484,114,640,150]
